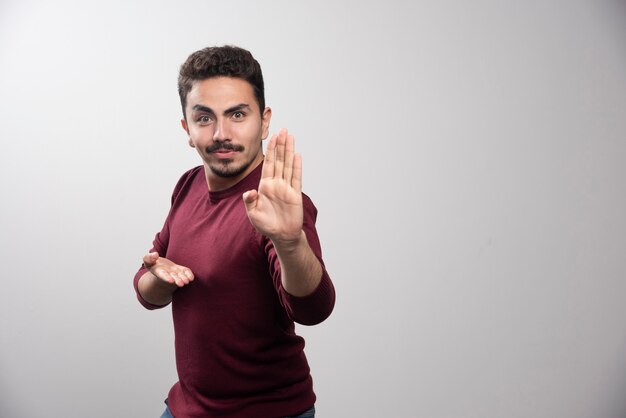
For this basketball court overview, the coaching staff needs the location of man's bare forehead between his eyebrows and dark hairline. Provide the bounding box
[187,77,258,112]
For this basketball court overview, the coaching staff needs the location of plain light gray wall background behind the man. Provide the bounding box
[0,0,626,418]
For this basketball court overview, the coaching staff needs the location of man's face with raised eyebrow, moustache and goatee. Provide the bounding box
[181,77,272,190]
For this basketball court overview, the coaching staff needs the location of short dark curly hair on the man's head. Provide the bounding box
[178,45,265,119]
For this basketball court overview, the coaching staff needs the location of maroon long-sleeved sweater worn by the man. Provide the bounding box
[134,165,335,418]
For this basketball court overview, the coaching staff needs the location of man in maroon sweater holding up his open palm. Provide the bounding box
[134,46,335,418]
